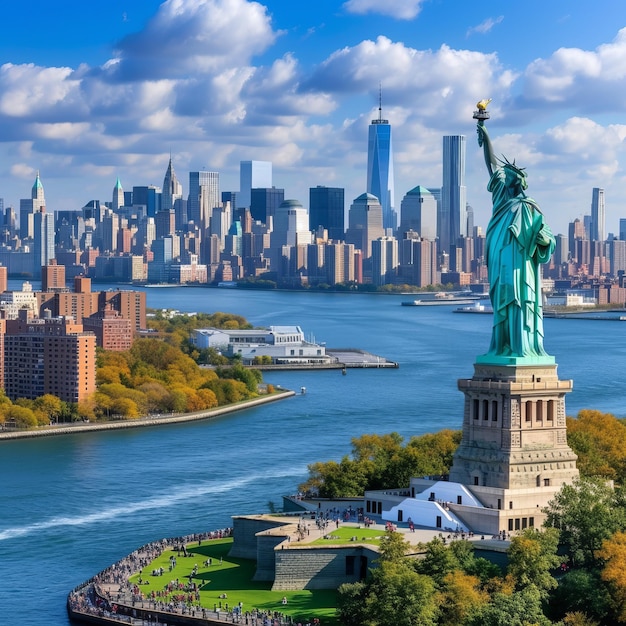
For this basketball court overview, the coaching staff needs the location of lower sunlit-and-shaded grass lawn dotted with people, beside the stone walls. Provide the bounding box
[129,529,338,626]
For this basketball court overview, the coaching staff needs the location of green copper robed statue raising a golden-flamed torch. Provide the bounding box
[474,100,555,365]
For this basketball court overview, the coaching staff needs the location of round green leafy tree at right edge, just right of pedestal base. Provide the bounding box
[544,478,626,567]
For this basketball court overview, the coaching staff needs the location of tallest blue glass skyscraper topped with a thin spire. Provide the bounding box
[366,91,398,230]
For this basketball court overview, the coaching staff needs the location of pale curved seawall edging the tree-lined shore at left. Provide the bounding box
[0,390,296,441]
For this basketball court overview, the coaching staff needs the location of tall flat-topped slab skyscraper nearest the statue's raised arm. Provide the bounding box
[439,135,467,270]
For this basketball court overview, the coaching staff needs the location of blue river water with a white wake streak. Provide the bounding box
[0,287,626,626]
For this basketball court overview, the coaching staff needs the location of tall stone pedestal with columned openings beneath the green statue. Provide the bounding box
[450,363,578,532]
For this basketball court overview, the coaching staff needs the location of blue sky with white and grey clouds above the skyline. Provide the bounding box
[0,0,626,233]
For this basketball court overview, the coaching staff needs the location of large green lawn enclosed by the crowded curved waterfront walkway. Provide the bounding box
[130,529,338,626]
